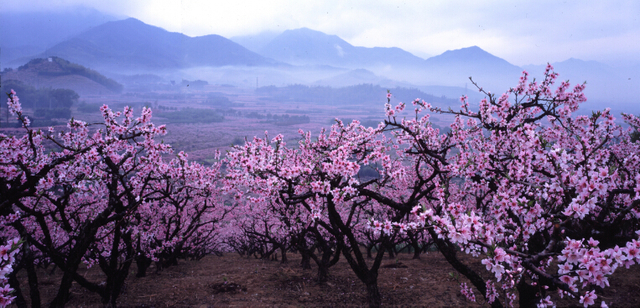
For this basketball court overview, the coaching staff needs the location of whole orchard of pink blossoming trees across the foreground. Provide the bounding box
[0,66,640,307]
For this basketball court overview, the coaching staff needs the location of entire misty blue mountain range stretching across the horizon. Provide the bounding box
[0,9,640,115]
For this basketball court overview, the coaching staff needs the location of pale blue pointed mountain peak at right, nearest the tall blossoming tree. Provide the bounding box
[417,46,522,93]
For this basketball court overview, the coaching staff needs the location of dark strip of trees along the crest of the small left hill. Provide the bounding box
[18,57,123,93]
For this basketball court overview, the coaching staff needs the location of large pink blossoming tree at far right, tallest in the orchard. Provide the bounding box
[388,66,640,307]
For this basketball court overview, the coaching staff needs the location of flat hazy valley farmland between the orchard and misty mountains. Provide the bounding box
[60,85,452,162]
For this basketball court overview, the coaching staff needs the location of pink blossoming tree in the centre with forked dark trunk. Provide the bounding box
[227,115,444,306]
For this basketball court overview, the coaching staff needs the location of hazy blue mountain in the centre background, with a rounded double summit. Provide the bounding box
[255,28,423,69]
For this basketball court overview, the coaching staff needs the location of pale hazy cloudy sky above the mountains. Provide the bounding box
[5,0,640,65]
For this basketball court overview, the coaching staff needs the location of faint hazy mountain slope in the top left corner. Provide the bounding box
[0,7,118,63]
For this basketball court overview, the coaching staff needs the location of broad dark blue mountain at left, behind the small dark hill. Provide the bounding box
[25,18,278,73]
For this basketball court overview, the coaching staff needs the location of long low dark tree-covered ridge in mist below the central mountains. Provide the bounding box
[255,84,459,107]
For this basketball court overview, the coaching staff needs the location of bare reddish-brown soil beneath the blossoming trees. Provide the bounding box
[8,252,640,308]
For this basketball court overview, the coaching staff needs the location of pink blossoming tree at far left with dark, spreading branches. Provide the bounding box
[0,93,230,307]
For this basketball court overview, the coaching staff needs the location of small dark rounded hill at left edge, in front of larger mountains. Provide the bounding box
[2,57,122,95]
